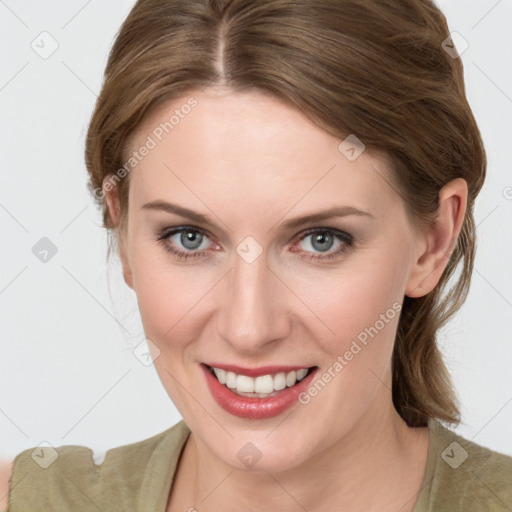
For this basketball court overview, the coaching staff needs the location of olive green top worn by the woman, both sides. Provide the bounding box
[7,419,512,512]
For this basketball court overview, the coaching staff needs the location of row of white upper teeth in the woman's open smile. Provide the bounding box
[213,368,308,398]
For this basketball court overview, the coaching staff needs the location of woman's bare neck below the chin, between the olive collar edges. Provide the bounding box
[169,386,428,512]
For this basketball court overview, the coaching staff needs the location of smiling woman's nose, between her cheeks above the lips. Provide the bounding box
[217,252,290,355]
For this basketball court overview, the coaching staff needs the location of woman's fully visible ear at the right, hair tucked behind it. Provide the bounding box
[405,178,468,297]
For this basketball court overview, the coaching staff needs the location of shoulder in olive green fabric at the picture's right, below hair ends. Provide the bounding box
[425,420,512,512]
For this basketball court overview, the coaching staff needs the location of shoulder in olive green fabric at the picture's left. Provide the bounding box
[8,420,190,512]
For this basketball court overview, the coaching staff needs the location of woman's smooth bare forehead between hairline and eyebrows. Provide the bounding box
[124,89,398,215]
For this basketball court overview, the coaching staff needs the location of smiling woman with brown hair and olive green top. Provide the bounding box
[2,0,512,512]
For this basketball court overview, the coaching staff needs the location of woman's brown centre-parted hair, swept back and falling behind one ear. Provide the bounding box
[86,0,486,427]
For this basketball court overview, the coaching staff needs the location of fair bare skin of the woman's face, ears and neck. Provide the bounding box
[101,88,467,512]
